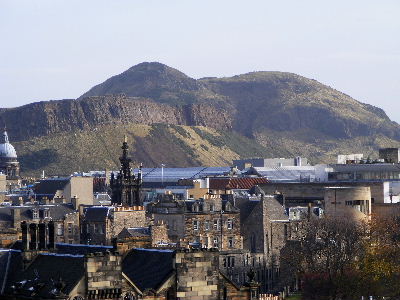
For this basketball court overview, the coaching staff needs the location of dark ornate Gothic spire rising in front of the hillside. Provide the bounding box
[110,136,143,206]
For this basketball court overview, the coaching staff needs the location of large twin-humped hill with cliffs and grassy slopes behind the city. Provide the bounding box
[0,63,400,174]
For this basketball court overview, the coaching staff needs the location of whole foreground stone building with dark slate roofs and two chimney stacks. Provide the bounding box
[0,245,259,300]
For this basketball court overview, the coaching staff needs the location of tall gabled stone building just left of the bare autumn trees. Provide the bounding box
[233,187,290,292]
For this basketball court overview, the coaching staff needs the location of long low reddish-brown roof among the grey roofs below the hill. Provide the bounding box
[209,177,268,190]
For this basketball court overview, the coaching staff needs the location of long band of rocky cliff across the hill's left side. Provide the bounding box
[0,95,232,141]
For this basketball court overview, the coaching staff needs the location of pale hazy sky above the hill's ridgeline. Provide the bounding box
[0,0,400,123]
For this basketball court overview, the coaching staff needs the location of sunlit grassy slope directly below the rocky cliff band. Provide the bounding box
[14,124,268,176]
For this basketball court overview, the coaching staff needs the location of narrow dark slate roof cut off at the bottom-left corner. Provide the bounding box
[0,249,22,295]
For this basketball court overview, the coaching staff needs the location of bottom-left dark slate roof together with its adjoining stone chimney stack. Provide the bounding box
[3,252,122,300]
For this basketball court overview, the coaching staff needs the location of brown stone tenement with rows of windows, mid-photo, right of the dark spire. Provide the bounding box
[148,194,243,250]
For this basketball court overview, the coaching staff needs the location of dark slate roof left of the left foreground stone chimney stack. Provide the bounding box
[11,253,85,299]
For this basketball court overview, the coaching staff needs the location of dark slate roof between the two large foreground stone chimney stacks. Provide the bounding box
[122,249,174,292]
